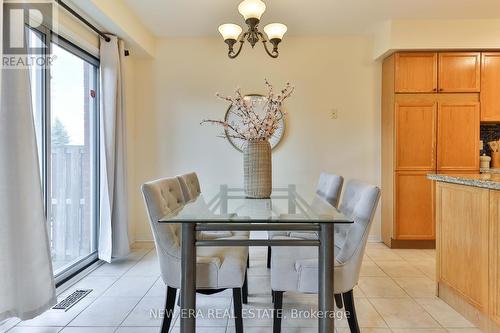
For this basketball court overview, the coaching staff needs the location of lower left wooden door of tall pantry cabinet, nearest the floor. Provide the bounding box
[395,171,436,240]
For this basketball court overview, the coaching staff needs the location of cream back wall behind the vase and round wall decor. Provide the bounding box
[129,38,381,240]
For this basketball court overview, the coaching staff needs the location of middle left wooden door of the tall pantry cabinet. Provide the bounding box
[395,96,437,170]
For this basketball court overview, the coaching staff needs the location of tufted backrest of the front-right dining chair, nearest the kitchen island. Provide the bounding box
[335,180,380,284]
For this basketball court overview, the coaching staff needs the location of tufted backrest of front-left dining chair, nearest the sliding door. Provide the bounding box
[141,178,184,285]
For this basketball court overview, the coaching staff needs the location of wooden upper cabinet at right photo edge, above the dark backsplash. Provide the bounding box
[481,52,500,122]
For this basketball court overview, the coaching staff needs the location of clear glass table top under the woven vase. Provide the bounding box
[159,185,352,223]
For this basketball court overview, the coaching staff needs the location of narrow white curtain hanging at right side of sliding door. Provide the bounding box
[99,36,130,262]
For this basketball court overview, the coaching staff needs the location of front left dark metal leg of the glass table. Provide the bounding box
[181,223,196,333]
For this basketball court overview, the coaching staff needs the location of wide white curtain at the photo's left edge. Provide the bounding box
[0,1,56,321]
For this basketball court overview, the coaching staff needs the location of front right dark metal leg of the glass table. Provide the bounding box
[318,223,335,333]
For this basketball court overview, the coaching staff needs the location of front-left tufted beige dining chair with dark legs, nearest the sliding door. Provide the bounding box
[142,178,248,333]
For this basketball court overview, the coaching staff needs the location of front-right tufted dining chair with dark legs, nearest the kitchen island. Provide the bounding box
[271,180,380,333]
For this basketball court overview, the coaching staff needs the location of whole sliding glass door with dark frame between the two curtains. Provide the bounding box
[29,30,99,281]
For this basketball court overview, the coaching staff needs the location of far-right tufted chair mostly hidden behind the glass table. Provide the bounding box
[267,172,344,268]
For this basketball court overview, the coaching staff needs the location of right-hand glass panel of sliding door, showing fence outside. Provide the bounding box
[48,43,98,274]
